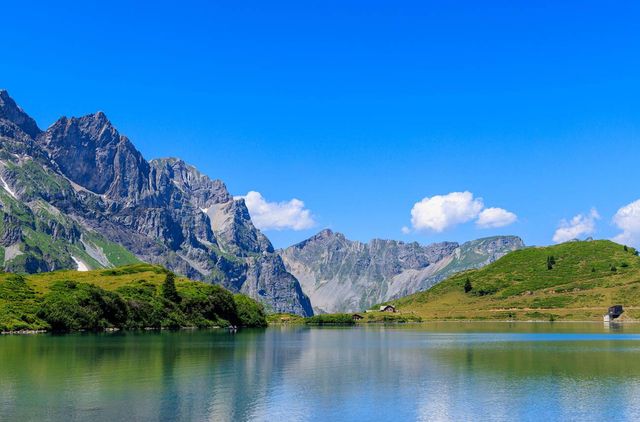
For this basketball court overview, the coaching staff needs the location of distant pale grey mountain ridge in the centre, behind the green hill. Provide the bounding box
[278,230,524,313]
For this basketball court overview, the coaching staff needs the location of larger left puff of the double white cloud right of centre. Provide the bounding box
[411,192,484,232]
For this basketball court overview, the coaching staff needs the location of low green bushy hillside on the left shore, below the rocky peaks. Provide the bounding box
[0,264,266,332]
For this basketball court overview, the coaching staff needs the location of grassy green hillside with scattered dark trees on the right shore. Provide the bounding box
[389,240,640,320]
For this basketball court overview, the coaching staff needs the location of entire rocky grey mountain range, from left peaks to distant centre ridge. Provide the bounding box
[0,90,523,316]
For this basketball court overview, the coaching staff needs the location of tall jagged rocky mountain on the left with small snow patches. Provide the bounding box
[0,90,313,316]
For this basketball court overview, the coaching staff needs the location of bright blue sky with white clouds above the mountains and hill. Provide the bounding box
[0,0,640,246]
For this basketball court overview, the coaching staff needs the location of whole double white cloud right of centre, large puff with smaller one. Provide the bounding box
[402,191,518,233]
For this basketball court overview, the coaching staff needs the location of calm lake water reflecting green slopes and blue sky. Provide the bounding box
[0,323,640,422]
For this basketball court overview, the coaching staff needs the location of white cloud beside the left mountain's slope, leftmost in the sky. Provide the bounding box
[240,191,316,230]
